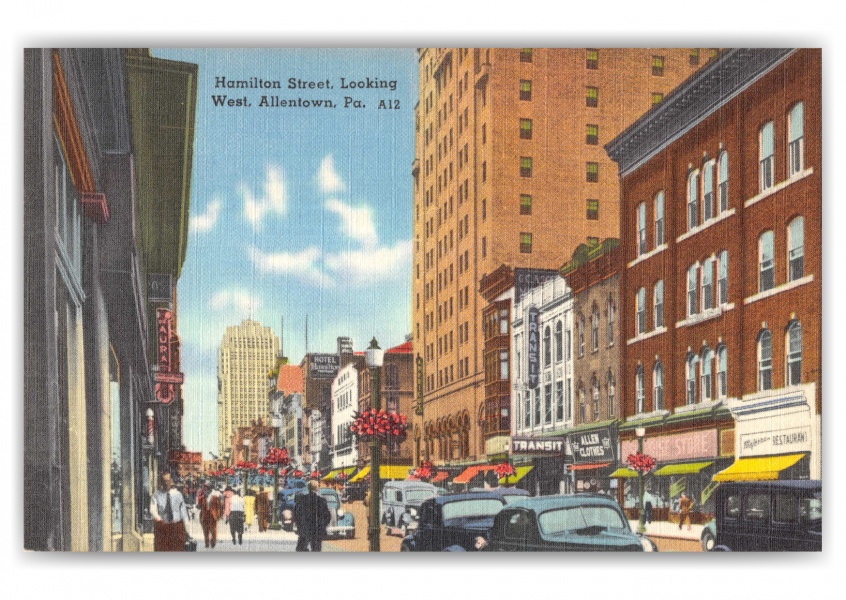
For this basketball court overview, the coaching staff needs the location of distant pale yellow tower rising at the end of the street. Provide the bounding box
[217,319,279,452]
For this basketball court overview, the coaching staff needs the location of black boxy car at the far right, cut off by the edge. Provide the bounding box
[703,480,822,552]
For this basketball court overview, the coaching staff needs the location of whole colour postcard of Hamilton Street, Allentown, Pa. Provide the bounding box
[23,47,822,553]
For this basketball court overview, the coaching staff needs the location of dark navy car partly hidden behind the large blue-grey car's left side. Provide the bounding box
[400,492,505,552]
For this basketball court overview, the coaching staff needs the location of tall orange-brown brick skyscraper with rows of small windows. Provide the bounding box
[412,48,714,464]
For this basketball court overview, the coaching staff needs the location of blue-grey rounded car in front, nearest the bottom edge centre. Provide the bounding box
[473,494,658,552]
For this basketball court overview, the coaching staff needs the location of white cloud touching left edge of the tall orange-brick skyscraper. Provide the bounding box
[324,240,411,285]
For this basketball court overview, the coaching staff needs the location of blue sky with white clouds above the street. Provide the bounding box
[153,48,417,453]
